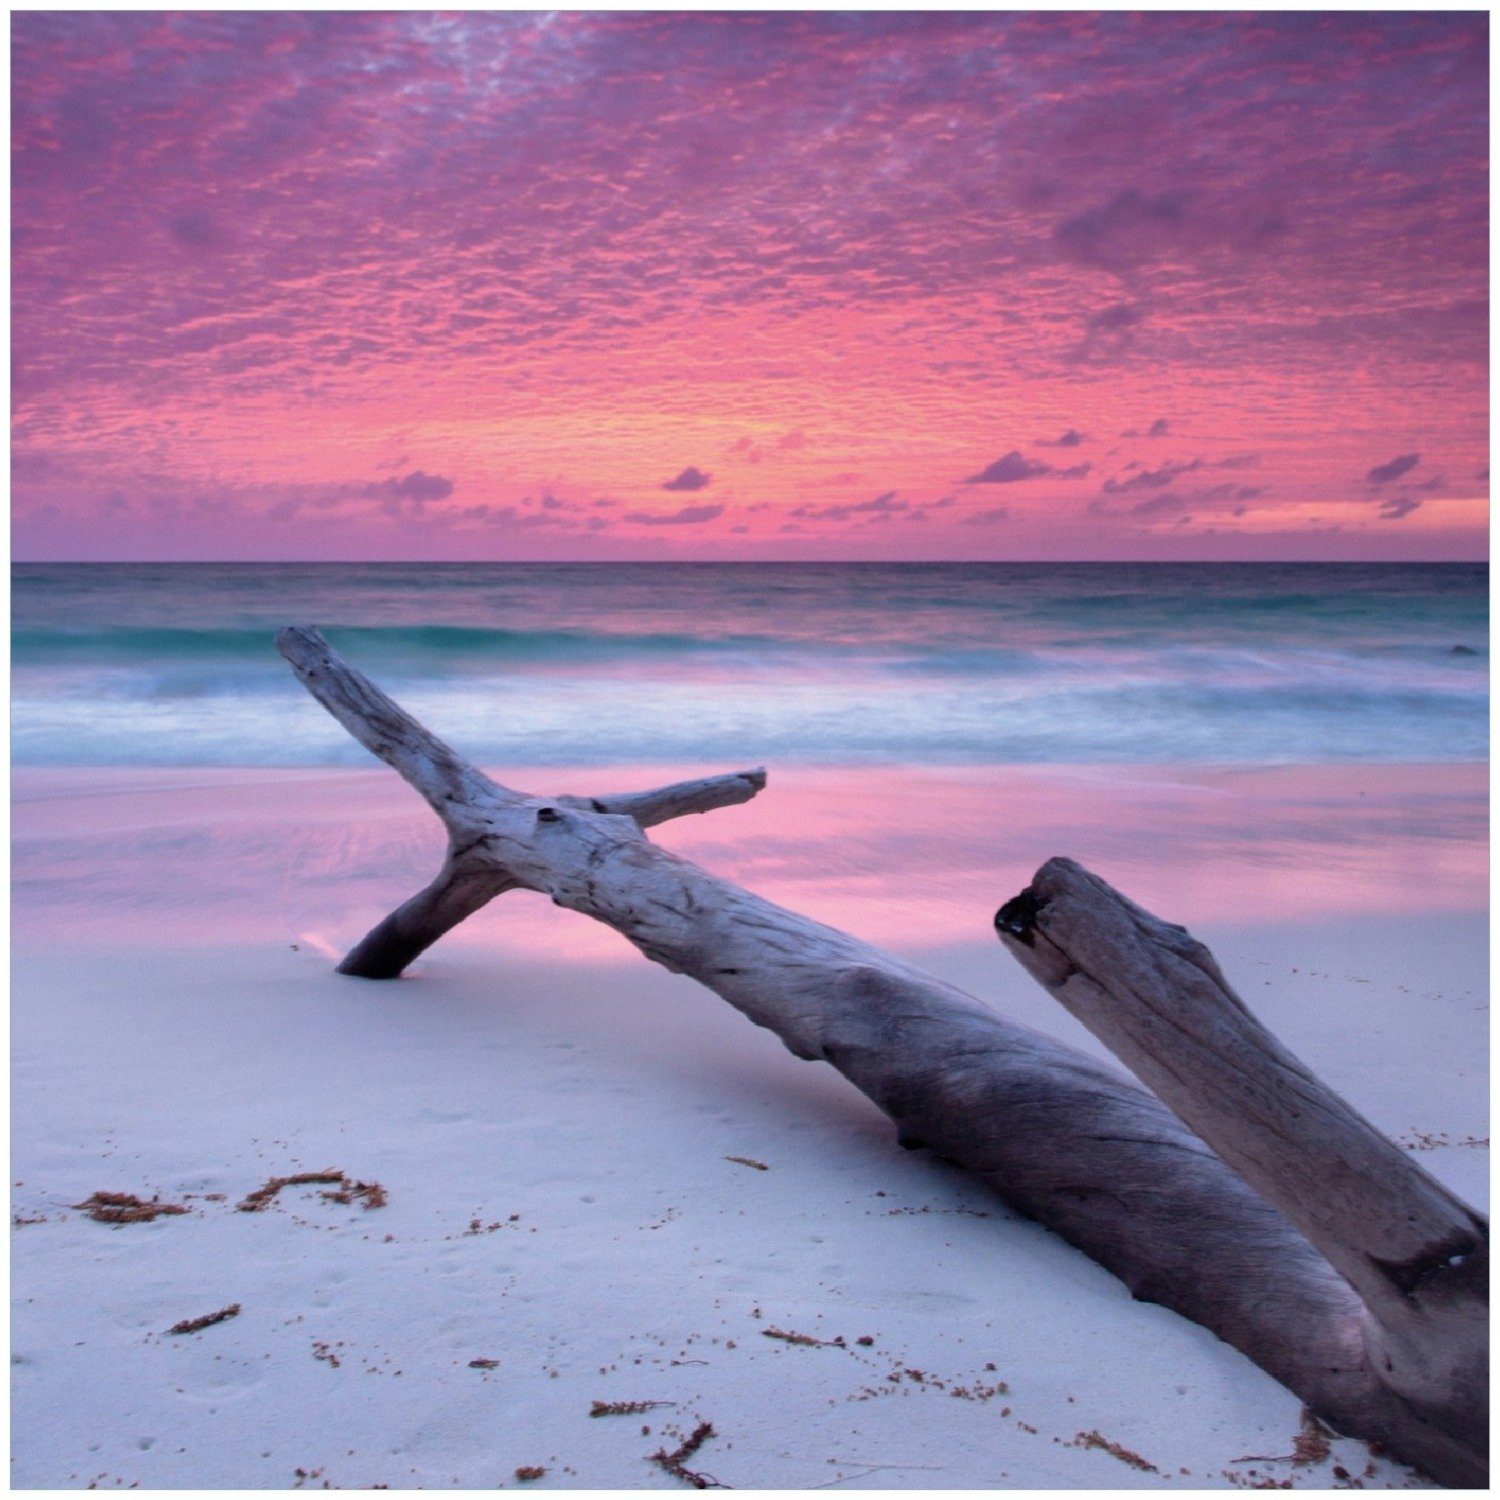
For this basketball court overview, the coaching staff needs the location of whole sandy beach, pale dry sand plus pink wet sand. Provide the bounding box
[12,768,1488,1488]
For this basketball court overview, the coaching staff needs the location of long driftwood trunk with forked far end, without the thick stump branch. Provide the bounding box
[278,630,1484,1484]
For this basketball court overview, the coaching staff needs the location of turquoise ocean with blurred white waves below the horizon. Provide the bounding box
[12,563,1488,767]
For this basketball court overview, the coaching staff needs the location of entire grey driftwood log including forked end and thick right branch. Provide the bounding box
[278,627,1488,1487]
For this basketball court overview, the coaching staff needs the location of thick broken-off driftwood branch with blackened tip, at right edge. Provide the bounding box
[995,860,1490,1482]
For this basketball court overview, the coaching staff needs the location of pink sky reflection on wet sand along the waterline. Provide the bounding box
[15,765,1487,962]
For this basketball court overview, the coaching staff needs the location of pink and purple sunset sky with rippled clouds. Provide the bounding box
[12,12,1488,561]
